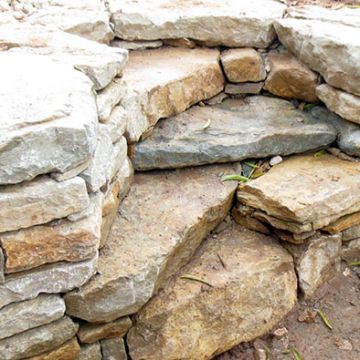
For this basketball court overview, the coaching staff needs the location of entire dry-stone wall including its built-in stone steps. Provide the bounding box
[0,0,360,360]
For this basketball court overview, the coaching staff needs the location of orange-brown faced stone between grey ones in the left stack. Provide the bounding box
[0,202,101,273]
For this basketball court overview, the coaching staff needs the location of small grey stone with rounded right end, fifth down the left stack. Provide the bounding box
[0,295,65,339]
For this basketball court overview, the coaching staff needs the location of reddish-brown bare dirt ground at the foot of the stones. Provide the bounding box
[216,267,360,360]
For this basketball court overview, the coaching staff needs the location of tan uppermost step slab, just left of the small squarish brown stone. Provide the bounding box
[116,48,224,142]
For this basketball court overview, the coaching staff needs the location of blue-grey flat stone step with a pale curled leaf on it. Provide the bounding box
[132,96,336,170]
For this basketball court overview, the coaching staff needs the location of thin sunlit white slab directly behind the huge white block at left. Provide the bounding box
[0,22,128,90]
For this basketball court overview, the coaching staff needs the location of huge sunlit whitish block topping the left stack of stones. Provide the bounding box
[0,52,97,185]
